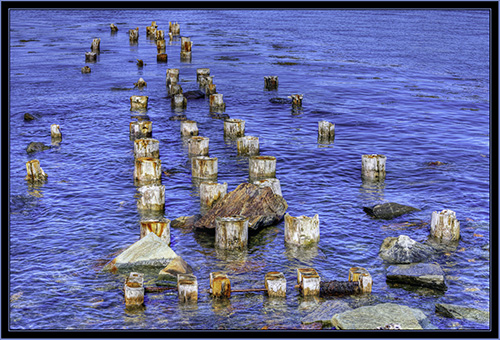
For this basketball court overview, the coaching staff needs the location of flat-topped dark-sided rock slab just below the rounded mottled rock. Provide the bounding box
[387,263,447,290]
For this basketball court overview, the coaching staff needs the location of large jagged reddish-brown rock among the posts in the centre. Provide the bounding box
[194,183,288,230]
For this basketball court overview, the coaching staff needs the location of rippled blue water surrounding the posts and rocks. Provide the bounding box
[9,10,490,330]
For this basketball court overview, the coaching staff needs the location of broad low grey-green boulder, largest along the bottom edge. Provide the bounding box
[332,303,429,329]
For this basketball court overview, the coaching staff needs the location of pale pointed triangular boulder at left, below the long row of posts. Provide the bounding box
[103,233,177,272]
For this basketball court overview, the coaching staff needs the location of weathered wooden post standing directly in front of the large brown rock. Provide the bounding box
[215,216,249,249]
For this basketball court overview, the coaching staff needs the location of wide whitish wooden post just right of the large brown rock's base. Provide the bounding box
[285,213,319,246]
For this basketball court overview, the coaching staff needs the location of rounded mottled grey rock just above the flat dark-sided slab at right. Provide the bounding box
[379,235,434,264]
